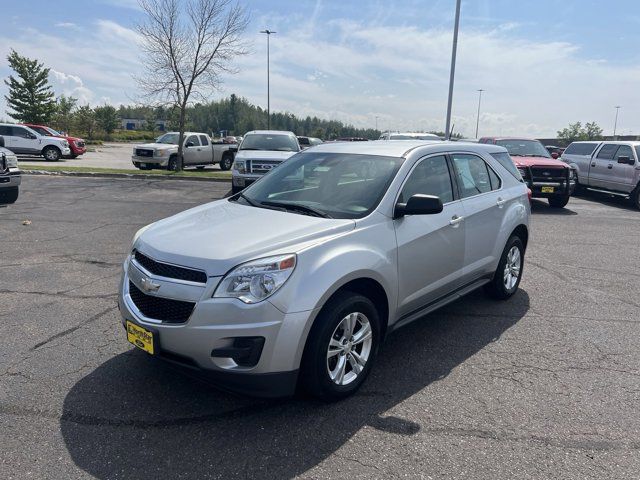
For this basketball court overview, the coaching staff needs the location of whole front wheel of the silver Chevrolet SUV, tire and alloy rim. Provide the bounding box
[300,291,380,401]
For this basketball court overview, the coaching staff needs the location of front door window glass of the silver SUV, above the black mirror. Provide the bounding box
[398,156,453,203]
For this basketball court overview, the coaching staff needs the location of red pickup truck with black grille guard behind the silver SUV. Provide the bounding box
[478,137,576,208]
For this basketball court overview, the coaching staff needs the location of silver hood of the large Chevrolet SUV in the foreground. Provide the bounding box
[135,199,355,276]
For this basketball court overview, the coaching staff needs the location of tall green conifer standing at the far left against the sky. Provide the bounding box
[4,49,56,123]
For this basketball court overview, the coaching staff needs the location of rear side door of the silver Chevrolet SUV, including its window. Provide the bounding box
[451,153,509,284]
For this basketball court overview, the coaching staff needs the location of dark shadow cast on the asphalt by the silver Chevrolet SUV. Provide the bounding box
[60,290,529,479]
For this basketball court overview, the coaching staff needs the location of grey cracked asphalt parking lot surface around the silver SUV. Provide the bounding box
[0,176,640,479]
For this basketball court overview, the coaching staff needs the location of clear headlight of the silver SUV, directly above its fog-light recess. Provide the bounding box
[213,254,296,303]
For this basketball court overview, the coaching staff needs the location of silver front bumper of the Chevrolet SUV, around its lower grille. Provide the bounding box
[118,258,314,397]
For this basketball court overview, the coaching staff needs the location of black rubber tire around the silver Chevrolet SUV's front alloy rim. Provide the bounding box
[300,291,381,401]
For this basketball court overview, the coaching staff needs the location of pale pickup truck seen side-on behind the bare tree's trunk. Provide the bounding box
[131,132,237,170]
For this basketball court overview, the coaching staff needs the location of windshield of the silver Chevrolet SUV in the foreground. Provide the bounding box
[237,153,403,218]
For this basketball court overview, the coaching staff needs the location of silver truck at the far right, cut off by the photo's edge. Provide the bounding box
[561,142,640,209]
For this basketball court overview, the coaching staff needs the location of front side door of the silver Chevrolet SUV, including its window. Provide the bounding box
[394,155,465,317]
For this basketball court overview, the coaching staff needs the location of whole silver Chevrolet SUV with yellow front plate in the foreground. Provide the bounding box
[119,141,530,400]
